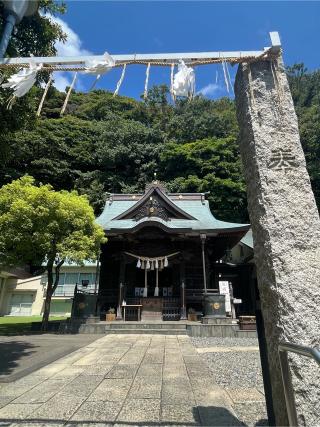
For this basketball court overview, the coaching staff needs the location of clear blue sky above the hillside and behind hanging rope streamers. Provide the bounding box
[50,1,320,98]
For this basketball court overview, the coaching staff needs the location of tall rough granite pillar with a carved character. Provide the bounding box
[235,59,320,426]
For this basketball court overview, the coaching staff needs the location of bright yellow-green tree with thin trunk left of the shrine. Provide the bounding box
[0,176,105,330]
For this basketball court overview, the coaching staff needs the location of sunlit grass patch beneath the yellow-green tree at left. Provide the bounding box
[0,316,66,335]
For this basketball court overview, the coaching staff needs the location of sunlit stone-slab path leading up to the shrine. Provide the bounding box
[0,335,248,427]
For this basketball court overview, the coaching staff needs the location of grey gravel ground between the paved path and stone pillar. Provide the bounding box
[191,338,268,426]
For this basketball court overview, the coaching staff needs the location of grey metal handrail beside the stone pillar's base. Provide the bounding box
[278,342,320,426]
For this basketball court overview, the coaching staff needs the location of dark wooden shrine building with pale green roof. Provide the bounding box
[97,181,250,320]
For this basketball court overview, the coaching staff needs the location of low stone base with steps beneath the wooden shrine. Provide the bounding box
[60,319,257,338]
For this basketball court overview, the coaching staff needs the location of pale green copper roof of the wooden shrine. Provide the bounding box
[96,188,250,234]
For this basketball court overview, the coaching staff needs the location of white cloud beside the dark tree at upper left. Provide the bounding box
[46,15,92,92]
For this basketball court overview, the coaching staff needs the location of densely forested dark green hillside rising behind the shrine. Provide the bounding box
[0,65,320,221]
